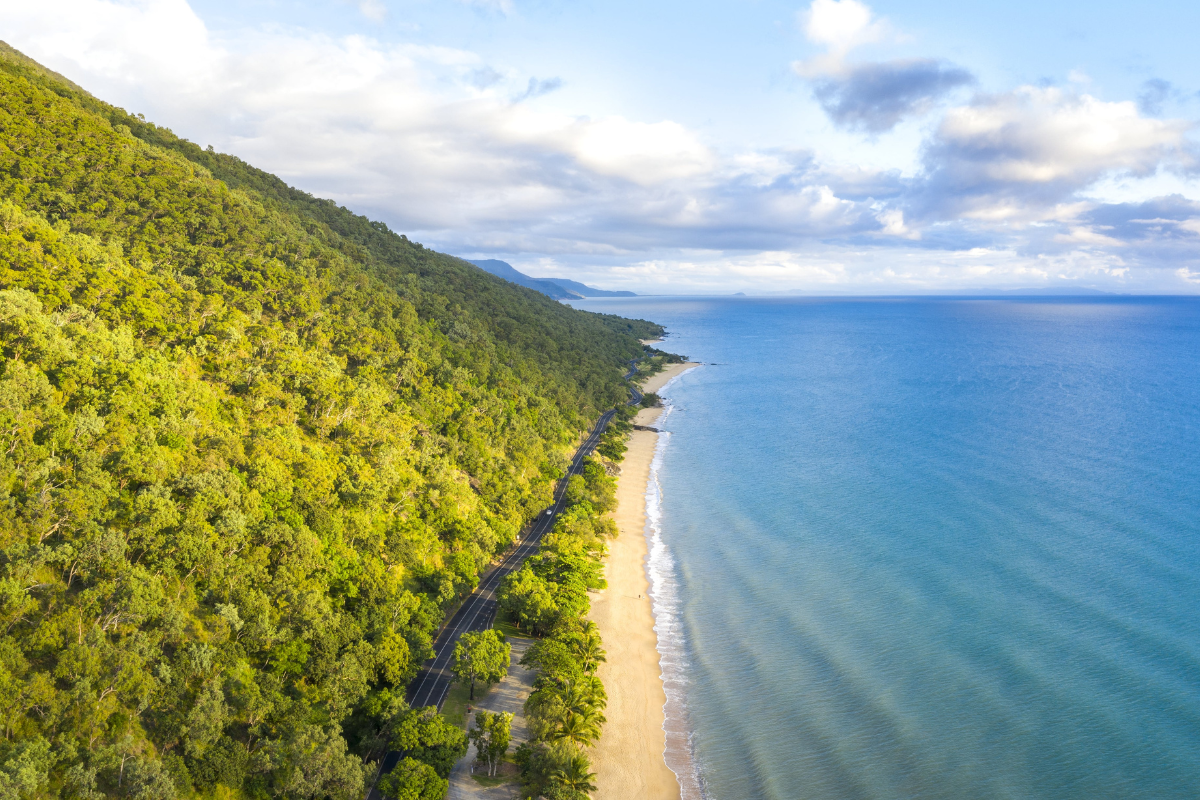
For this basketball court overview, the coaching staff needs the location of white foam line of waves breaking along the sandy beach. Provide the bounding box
[643,375,704,800]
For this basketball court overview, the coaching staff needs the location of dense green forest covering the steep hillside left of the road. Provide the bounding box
[0,48,662,799]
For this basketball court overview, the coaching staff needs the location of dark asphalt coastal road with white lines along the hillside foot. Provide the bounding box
[366,367,642,800]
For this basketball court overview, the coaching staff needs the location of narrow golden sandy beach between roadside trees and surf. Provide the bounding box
[592,363,697,800]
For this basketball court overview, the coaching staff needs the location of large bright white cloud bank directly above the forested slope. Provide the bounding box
[0,0,729,231]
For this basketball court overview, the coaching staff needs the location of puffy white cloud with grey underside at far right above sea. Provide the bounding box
[923,86,1193,222]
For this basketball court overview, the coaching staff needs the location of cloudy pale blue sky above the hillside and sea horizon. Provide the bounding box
[7,0,1200,294]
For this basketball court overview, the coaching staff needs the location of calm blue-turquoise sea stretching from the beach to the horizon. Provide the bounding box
[576,297,1200,800]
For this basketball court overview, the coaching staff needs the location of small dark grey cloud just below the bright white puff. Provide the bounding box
[814,59,974,133]
